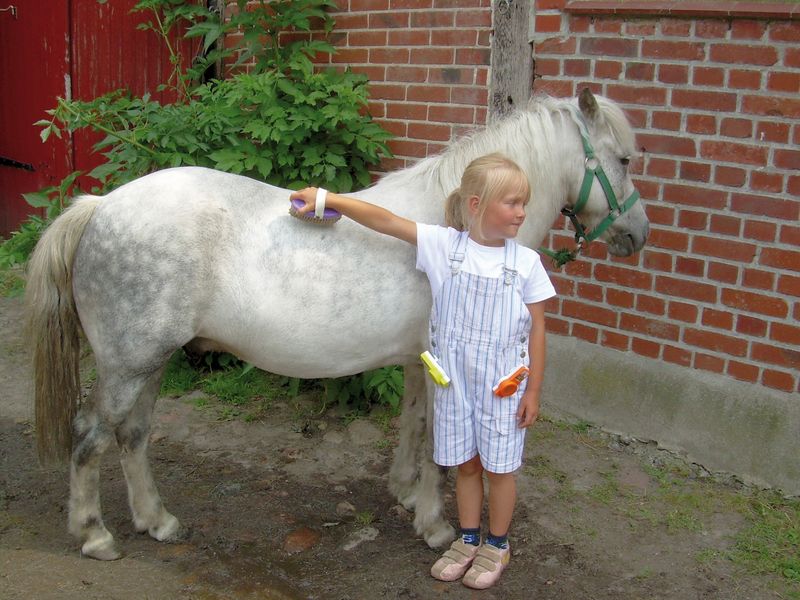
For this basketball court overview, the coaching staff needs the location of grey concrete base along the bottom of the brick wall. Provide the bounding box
[542,335,800,496]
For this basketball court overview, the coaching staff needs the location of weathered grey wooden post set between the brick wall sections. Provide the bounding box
[489,0,533,121]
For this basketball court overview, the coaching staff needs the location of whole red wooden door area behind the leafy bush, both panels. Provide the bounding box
[0,0,194,236]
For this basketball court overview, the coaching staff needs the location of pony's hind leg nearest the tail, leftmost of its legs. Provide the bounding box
[68,369,166,560]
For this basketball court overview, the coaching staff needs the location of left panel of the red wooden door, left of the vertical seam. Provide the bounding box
[0,0,72,236]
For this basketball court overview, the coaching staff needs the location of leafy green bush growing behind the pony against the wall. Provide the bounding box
[7,0,402,408]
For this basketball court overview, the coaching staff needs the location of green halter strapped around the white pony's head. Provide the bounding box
[539,110,639,267]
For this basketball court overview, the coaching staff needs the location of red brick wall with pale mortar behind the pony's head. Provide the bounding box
[252,0,800,392]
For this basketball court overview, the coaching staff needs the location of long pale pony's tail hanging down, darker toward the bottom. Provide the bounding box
[25,196,100,464]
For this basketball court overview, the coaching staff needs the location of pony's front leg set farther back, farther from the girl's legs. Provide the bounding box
[389,363,427,510]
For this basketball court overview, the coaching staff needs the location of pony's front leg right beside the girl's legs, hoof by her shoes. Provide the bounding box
[414,377,456,548]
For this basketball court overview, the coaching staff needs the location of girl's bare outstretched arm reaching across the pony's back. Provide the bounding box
[289,188,417,246]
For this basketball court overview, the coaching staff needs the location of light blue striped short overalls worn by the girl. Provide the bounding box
[430,232,531,473]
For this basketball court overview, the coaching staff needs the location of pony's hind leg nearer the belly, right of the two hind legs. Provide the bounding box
[116,369,180,542]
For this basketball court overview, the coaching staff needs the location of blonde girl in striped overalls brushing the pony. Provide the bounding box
[291,154,555,589]
